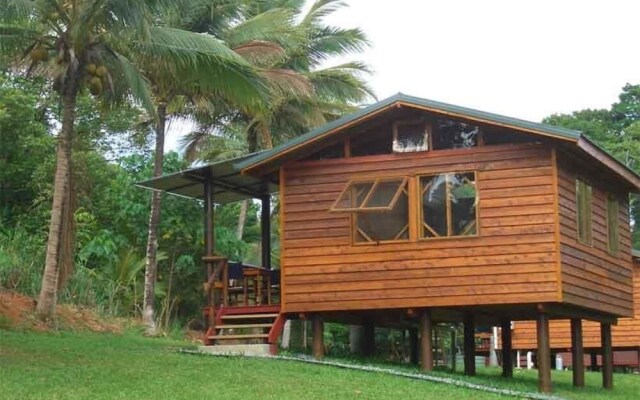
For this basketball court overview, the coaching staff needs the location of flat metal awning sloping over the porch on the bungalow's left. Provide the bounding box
[136,154,278,204]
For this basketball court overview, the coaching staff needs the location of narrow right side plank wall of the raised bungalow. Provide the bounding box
[558,153,633,317]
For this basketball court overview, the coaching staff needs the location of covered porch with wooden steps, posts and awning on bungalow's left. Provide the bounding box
[137,155,284,353]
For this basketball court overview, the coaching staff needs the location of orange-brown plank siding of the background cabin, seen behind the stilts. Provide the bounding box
[513,261,640,350]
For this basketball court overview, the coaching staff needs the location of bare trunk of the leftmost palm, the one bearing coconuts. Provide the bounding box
[36,73,79,320]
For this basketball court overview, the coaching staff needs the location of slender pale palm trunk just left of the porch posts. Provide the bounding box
[142,103,167,335]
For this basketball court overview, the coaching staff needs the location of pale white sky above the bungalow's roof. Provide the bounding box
[168,0,640,148]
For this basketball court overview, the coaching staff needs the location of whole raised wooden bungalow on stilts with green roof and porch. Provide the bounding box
[141,94,640,391]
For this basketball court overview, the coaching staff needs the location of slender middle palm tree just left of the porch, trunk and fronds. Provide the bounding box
[134,2,263,334]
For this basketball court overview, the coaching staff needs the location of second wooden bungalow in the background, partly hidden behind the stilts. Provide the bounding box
[512,252,640,371]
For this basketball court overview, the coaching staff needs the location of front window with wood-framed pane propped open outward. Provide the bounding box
[331,178,409,243]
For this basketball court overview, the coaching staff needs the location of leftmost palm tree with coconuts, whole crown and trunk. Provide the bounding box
[0,0,257,319]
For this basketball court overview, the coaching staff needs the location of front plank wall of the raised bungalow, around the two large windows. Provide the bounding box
[280,144,560,313]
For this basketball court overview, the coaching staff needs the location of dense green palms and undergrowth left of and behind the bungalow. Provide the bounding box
[0,0,372,329]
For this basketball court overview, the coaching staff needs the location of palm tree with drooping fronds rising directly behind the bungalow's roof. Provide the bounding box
[182,0,375,239]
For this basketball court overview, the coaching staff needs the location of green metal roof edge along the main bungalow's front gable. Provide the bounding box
[237,93,581,170]
